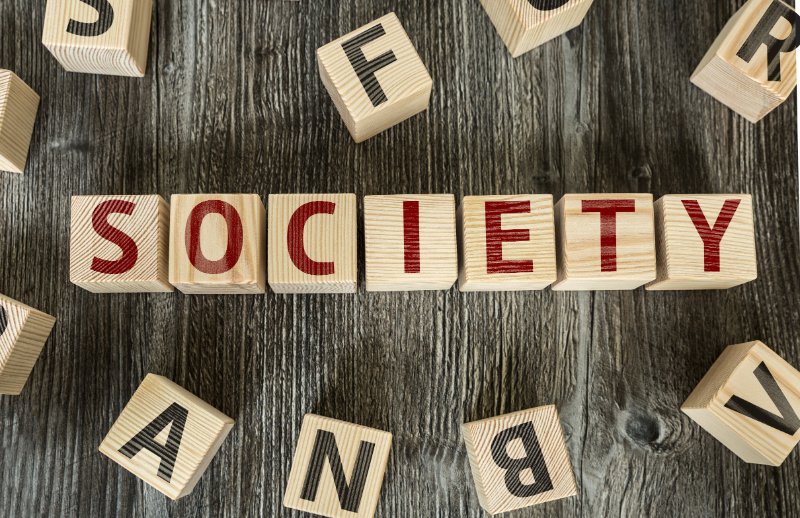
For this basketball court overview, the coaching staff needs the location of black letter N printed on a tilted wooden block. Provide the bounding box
[300,430,375,513]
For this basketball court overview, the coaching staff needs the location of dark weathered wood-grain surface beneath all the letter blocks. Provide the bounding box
[0,0,800,517]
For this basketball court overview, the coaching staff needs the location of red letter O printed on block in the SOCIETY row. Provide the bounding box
[186,200,244,274]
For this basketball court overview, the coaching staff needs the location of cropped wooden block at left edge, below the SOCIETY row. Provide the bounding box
[0,295,56,396]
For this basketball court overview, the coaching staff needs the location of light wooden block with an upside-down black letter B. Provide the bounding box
[462,405,578,514]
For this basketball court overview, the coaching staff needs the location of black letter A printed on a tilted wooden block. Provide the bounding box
[119,403,189,482]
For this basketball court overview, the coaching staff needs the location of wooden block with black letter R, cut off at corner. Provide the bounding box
[692,0,800,122]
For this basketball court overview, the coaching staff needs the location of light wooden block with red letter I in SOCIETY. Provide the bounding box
[364,194,458,291]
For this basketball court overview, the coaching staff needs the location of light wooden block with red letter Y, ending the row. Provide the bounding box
[647,194,758,290]
